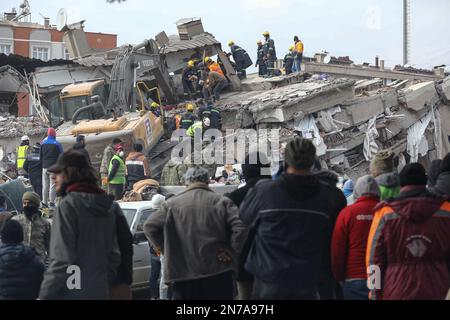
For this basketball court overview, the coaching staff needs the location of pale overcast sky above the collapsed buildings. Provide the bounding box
[0,0,450,68]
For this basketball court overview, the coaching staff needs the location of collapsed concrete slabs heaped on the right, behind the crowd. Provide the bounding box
[219,75,450,178]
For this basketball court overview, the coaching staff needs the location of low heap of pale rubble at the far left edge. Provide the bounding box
[0,113,48,139]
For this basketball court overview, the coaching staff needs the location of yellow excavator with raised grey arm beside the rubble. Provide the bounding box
[52,40,175,178]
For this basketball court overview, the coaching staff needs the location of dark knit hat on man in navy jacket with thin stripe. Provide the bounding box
[284,138,316,170]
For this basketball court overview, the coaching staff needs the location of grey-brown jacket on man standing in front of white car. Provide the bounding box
[144,183,247,282]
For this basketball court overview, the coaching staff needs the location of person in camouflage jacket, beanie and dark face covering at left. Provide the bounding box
[13,192,51,265]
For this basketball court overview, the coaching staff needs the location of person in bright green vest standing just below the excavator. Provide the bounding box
[107,143,126,201]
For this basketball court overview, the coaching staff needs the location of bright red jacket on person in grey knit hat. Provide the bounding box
[331,196,379,282]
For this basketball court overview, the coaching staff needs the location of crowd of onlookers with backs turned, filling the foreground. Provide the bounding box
[0,134,450,300]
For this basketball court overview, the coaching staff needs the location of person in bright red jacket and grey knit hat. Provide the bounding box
[331,176,380,300]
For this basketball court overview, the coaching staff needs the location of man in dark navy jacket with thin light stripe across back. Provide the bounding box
[240,138,345,300]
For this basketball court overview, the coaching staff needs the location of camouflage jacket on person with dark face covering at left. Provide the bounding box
[13,211,51,263]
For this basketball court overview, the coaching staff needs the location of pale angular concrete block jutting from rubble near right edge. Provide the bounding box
[399,81,439,111]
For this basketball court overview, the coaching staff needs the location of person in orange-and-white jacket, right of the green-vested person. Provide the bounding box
[125,143,150,190]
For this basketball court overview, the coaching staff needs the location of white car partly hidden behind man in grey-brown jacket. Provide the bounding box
[119,184,237,289]
